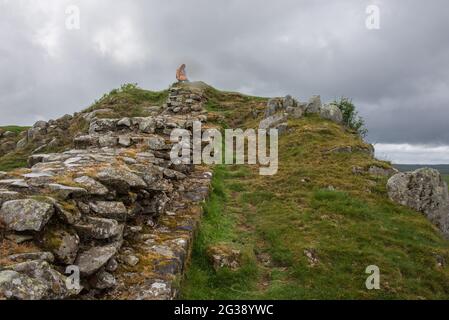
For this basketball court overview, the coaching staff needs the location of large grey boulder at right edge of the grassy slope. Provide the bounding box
[387,168,449,238]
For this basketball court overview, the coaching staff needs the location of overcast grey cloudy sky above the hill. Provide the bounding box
[0,0,449,163]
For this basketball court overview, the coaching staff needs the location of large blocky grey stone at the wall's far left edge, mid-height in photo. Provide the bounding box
[0,199,55,231]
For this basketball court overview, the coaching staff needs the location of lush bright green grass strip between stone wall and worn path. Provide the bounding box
[182,166,258,300]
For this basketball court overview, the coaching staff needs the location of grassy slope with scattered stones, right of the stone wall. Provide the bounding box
[181,92,449,299]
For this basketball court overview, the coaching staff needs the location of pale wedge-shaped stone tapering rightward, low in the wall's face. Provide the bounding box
[75,245,117,276]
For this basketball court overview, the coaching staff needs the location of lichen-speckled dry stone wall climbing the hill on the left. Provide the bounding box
[0,87,211,299]
